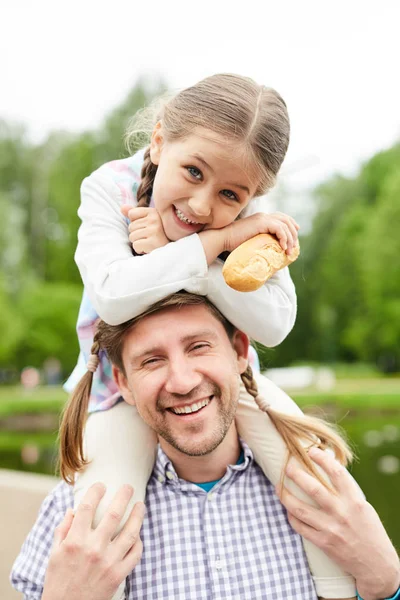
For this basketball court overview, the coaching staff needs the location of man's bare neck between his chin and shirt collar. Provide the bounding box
[159,423,241,483]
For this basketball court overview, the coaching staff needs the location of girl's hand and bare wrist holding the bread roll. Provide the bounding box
[221,212,300,255]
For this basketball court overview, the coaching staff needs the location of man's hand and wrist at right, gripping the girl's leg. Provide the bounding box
[281,448,400,600]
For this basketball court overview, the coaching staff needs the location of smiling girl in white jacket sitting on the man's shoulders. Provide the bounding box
[61,75,354,598]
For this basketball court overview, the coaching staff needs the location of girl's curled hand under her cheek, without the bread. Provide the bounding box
[121,204,169,254]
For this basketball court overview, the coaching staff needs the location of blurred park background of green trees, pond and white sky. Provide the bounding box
[0,0,400,596]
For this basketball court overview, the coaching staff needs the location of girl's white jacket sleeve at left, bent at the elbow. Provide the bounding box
[75,168,208,325]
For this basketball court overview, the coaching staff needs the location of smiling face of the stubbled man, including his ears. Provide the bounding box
[113,305,248,456]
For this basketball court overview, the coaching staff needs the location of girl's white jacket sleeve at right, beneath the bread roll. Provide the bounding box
[208,198,297,347]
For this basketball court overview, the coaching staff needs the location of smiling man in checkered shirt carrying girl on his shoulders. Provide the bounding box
[12,295,400,600]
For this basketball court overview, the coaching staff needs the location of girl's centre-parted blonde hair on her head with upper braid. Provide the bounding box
[125,74,290,206]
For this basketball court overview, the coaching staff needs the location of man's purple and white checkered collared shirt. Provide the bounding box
[11,444,317,600]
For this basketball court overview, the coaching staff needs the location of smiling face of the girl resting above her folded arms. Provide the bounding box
[150,124,259,241]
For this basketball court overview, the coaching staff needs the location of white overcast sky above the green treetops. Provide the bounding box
[0,0,400,195]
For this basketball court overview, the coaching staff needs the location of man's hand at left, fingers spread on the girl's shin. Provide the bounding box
[42,483,145,600]
